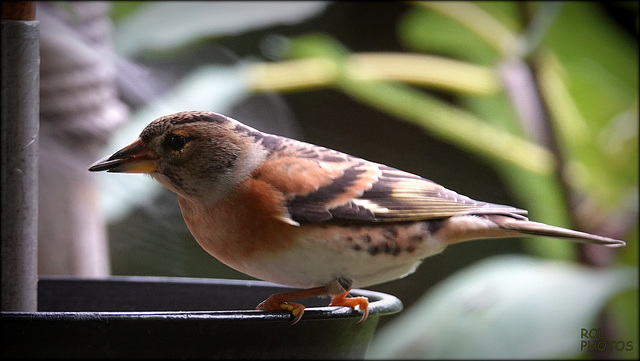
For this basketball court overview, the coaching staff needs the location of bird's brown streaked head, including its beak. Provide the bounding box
[89,111,267,201]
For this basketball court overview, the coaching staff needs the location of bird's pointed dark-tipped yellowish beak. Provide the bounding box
[89,139,157,173]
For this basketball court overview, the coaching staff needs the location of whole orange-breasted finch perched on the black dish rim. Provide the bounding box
[89,111,625,324]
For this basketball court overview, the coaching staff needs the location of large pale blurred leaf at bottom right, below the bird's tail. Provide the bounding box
[367,256,638,359]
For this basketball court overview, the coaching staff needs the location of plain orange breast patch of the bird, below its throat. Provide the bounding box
[178,178,300,267]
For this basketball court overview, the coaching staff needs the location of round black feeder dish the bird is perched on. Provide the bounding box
[2,276,402,359]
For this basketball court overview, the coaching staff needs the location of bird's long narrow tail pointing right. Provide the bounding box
[490,216,626,247]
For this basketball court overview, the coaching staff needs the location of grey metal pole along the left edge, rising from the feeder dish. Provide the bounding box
[0,1,40,312]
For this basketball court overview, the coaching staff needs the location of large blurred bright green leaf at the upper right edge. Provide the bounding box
[540,2,639,210]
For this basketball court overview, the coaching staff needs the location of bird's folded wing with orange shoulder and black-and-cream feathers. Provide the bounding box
[255,137,527,224]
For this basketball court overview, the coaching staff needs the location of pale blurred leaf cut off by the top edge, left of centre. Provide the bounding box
[114,1,327,58]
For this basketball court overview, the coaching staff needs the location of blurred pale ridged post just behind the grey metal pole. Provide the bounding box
[36,2,128,277]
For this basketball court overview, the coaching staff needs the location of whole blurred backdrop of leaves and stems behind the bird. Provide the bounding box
[37,1,640,359]
